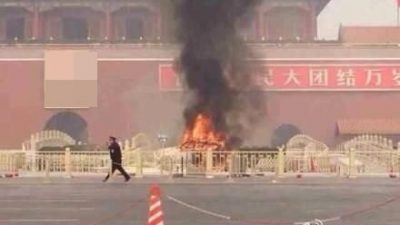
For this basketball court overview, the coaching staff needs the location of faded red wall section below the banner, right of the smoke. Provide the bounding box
[267,91,400,145]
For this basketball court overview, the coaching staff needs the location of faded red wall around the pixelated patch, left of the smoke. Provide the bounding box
[0,61,180,148]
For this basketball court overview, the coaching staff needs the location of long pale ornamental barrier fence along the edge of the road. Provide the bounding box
[0,148,400,177]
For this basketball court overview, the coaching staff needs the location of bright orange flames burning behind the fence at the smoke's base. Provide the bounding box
[181,113,225,150]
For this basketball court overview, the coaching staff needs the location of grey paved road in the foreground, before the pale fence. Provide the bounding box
[0,177,400,225]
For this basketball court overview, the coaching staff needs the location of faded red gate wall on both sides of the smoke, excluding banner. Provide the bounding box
[0,61,400,148]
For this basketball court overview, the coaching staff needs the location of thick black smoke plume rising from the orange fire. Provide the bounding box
[172,0,262,147]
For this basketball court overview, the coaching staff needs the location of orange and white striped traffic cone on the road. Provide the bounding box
[147,185,164,225]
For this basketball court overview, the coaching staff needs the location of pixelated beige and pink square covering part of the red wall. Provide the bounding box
[44,50,97,108]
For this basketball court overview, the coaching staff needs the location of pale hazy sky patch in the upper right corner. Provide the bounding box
[318,0,397,39]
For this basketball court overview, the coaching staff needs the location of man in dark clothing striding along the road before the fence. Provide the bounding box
[103,136,131,182]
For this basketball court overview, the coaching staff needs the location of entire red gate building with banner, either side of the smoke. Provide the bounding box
[0,0,400,148]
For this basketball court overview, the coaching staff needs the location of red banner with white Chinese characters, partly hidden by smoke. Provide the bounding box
[159,64,400,91]
